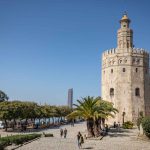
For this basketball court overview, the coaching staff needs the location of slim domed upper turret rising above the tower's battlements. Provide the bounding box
[117,14,133,52]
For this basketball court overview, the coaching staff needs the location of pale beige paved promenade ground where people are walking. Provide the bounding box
[13,122,150,150]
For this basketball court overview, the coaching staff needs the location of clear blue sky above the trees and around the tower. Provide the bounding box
[0,0,150,105]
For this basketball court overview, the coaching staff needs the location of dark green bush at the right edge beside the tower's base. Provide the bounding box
[142,117,150,138]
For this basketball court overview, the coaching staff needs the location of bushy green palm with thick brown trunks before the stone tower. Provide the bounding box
[67,96,117,137]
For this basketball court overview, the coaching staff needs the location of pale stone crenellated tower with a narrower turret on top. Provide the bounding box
[101,14,150,123]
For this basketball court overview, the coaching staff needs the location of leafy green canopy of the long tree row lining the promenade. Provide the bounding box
[0,100,71,130]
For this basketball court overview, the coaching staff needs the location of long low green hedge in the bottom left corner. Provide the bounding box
[0,134,41,150]
